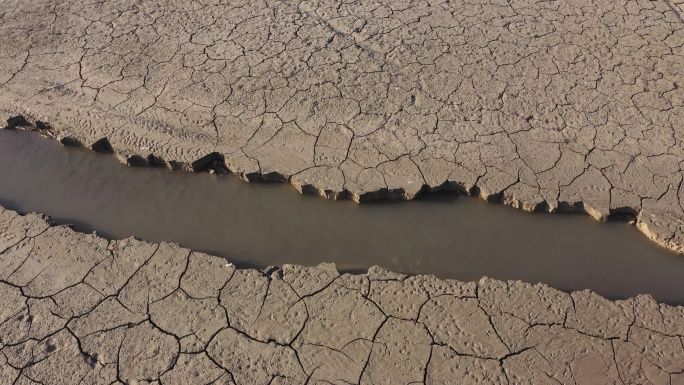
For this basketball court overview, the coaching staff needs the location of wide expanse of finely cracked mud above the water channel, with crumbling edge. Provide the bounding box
[0,0,684,252]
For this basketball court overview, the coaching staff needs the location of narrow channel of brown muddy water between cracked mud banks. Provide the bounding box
[0,130,684,304]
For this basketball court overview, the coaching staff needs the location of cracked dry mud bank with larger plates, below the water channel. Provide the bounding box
[0,207,684,385]
